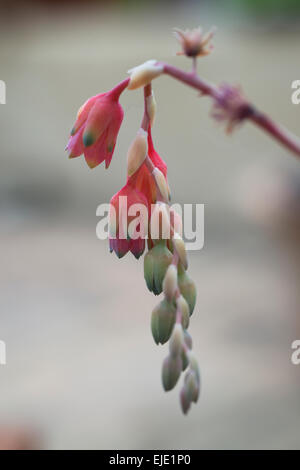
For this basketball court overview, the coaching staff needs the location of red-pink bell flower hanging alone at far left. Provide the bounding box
[66,79,129,168]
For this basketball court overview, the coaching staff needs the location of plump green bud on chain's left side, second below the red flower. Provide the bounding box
[151,299,176,344]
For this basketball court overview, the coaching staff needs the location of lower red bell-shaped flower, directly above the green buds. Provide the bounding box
[109,180,148,259]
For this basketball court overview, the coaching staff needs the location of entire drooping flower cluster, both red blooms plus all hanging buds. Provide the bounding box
[67,40,200,413]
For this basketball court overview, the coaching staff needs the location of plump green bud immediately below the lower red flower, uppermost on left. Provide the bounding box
[144,241,172,295]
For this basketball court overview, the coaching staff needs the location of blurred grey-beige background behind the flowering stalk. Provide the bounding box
[0,0,300,449]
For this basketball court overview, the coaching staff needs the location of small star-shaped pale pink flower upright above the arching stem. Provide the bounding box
[174,27,214,57]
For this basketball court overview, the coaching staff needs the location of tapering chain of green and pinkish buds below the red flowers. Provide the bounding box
[144,233,200,413]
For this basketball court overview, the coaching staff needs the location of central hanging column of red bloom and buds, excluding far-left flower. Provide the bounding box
[110,105,200,413]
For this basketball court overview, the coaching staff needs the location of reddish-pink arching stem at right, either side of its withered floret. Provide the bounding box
[159,62,300,157]
